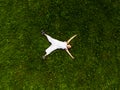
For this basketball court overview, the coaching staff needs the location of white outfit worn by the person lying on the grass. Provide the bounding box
[45,34,67,55]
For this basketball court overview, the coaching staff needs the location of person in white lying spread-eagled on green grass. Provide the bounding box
[42,31,77,59]
